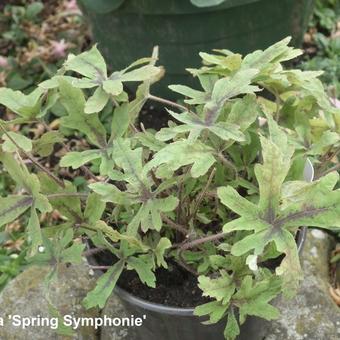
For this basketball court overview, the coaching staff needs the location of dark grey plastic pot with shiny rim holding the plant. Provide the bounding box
[89,228,306,340]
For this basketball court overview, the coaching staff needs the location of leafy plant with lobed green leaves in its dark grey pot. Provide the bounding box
[0,38,340,340]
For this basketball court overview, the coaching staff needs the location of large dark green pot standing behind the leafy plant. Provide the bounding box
[78,0,313,98]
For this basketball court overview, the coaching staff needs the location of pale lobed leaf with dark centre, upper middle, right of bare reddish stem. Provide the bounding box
[156,69,260,142]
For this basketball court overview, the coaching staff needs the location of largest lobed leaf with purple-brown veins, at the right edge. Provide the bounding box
[218,137,340,296]
